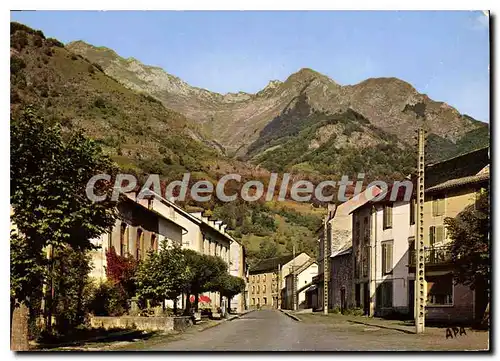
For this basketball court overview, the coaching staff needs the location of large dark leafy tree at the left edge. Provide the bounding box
[10,108,116,348]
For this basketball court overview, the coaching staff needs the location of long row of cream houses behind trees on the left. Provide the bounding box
[91,191,247,311]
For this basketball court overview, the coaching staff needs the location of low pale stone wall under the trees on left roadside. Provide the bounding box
[90,316,192,332]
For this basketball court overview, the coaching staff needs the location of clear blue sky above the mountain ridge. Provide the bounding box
[11,11,489,121]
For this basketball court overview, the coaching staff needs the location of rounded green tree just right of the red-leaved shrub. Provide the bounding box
[136,242,191,313]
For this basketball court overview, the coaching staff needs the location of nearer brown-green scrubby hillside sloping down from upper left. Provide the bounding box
[10,23,324,259]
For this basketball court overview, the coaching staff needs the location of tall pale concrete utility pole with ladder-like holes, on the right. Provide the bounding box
[415,128,427,333]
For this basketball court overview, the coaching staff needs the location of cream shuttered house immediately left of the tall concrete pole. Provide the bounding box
[352,184,414,316]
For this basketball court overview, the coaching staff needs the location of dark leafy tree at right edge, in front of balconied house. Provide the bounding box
[445,191,490,289]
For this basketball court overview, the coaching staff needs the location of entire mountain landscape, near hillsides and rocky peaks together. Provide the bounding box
[10,23,489,258]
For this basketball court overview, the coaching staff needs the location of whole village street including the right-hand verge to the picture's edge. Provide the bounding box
[133,310,488,351]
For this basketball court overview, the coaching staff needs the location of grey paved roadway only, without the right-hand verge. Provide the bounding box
[150,310,359,351]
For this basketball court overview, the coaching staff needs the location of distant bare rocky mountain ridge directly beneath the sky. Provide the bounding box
[67,41,488,165]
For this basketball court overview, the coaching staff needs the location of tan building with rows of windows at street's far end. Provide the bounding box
[248,253,310,308]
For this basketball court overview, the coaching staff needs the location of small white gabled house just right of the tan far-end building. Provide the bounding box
[282,257,318,310]
